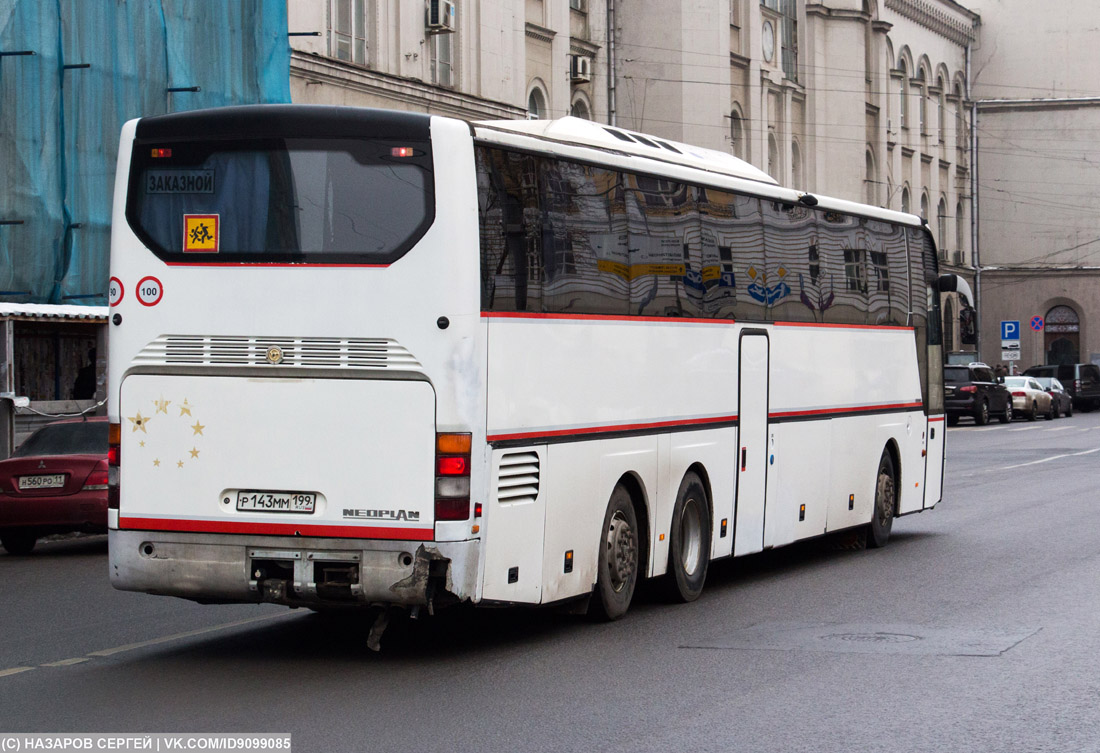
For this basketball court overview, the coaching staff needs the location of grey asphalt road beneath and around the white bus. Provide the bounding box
[0,412,1100,753]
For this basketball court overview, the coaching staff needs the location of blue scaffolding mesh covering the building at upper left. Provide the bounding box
[0,0,290,306]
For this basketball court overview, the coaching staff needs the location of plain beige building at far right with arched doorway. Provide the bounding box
[974,0,1100,367]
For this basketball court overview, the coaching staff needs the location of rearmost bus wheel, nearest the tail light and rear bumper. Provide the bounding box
[589,484,640,620]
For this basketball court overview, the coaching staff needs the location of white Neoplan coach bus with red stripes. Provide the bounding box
[109,106,946,619]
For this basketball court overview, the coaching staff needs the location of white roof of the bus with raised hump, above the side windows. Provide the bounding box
[472,117,924,228]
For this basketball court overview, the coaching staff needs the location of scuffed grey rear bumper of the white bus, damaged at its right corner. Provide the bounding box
[109,529,481,607]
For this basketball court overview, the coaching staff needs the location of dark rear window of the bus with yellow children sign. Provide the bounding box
[127,139,435,264]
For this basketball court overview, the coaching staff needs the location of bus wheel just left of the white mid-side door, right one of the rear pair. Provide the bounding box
[667,473,712,603]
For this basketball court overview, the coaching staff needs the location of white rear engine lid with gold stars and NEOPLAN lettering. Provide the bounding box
[120,374,436,540]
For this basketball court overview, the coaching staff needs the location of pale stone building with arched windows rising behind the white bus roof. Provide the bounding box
[288,0,979,352]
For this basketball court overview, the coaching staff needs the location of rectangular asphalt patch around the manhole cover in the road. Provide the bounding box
[680,622,1038,656]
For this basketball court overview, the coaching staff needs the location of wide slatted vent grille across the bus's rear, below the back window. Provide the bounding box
[134,334,421,372]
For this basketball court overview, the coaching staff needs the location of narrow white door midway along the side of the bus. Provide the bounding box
[734,330,769,555]
